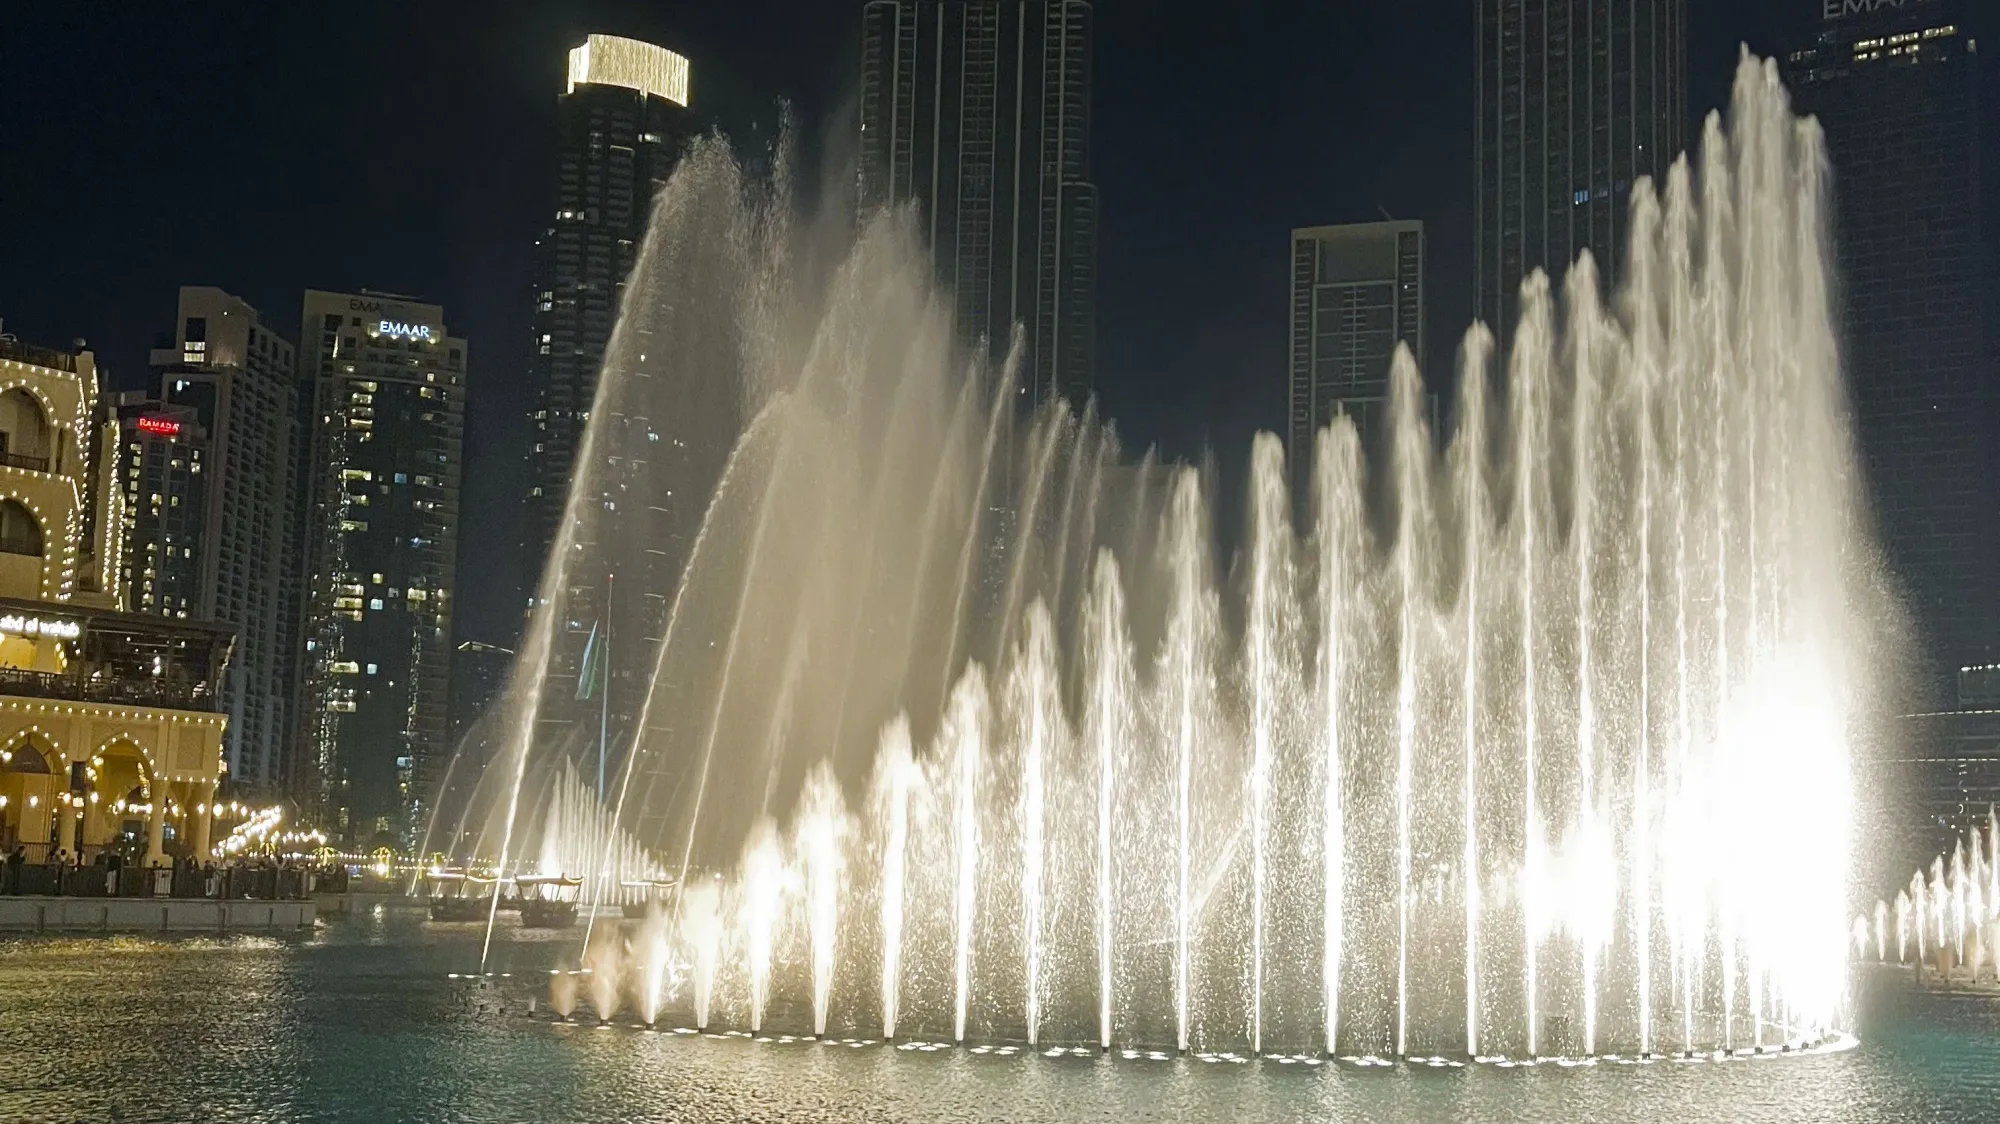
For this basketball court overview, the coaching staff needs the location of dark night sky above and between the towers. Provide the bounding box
[0,0,2000,640]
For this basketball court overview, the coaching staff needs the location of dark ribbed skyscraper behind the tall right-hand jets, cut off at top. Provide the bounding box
[1472,0,1686,354]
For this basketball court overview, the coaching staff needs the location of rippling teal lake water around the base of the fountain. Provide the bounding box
[0,910,2000,1124]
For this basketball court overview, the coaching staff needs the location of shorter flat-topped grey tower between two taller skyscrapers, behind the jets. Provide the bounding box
[1286,222,1436,492]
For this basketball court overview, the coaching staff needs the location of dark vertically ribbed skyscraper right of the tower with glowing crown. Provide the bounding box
[860,0,1098,406]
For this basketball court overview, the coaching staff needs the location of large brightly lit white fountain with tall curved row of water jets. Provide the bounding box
[458,60,1868,1064]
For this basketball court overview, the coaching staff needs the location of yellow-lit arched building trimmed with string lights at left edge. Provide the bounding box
[0,338,232,862]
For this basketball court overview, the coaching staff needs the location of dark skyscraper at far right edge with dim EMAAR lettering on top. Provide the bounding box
[1784,0,2000,688]
